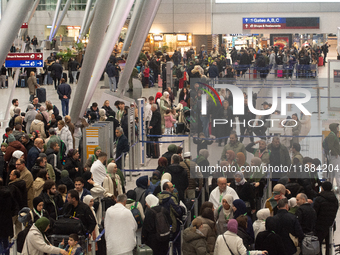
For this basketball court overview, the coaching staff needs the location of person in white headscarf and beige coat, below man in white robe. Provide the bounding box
[214,194,234,235]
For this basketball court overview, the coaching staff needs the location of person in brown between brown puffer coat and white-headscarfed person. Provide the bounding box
[196,207,217,255]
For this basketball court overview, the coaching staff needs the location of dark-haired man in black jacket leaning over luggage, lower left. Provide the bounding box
[63,189,96,234]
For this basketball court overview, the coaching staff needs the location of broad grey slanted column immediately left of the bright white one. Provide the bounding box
[70,0,115,123]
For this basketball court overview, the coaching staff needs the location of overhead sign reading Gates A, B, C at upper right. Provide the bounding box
[243,17,320,29]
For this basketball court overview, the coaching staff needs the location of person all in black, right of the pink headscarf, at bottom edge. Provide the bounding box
[255,217,287,255]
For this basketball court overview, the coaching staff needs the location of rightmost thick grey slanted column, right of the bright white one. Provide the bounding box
[118,0,161,97]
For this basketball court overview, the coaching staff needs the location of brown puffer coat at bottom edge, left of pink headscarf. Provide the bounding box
[182,227,209,255]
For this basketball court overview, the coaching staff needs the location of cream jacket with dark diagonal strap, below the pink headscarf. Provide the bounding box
[214,231,262,255]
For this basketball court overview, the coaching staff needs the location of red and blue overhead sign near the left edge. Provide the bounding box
[5,53,44,67]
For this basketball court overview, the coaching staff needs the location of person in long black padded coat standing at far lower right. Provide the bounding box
[313,181,339,255]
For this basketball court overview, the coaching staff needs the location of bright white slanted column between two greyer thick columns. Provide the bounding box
[79,0,134,118]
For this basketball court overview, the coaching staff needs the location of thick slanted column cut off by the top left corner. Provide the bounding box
[0,0,34,65]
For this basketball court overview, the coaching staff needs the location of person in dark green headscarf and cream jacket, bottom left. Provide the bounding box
[22,217,68,255]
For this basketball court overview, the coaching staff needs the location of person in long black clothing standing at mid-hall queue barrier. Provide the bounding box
[147,104,162,158]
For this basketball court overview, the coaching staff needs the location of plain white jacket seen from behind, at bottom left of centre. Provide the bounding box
[104,203,137,255]
